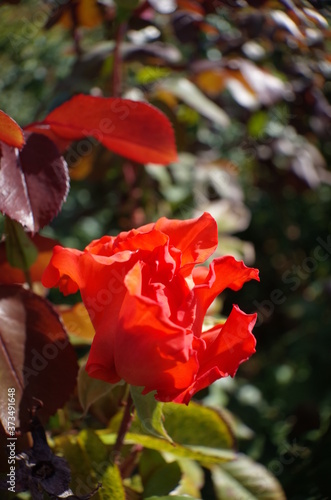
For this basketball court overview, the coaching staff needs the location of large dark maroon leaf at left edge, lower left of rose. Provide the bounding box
[0,285,78,430]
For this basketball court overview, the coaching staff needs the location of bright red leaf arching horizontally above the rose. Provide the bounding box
[26,94,177,164]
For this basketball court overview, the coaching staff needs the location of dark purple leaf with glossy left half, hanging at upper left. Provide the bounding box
[0,134,69,233]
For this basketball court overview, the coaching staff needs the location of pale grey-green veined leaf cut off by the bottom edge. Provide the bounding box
[211,455,286,500]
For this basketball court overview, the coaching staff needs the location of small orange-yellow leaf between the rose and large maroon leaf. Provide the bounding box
[57,302,95,344]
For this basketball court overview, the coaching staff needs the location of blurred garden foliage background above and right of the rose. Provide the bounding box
[0,0,331,500]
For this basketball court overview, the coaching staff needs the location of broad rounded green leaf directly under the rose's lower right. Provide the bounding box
[163,401,234,450]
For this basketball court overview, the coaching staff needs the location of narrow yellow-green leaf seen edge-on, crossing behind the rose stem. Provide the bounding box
[98,431,236,464]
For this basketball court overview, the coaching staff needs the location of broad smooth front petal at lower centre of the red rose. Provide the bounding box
[115,296,197,391]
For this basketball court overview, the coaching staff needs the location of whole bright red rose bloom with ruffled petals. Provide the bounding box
[42,213,259,404]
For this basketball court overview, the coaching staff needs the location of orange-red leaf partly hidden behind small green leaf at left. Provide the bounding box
[0,234,58,285]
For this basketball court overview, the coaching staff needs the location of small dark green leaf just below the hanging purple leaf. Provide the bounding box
[5,217,38,272]
